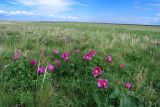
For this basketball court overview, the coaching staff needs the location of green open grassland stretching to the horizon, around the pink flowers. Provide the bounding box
[0,22,160,107]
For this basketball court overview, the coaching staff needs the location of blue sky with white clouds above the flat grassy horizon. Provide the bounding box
[0,0,160,25]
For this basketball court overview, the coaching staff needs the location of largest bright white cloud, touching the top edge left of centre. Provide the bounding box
[16,0,82,15]
